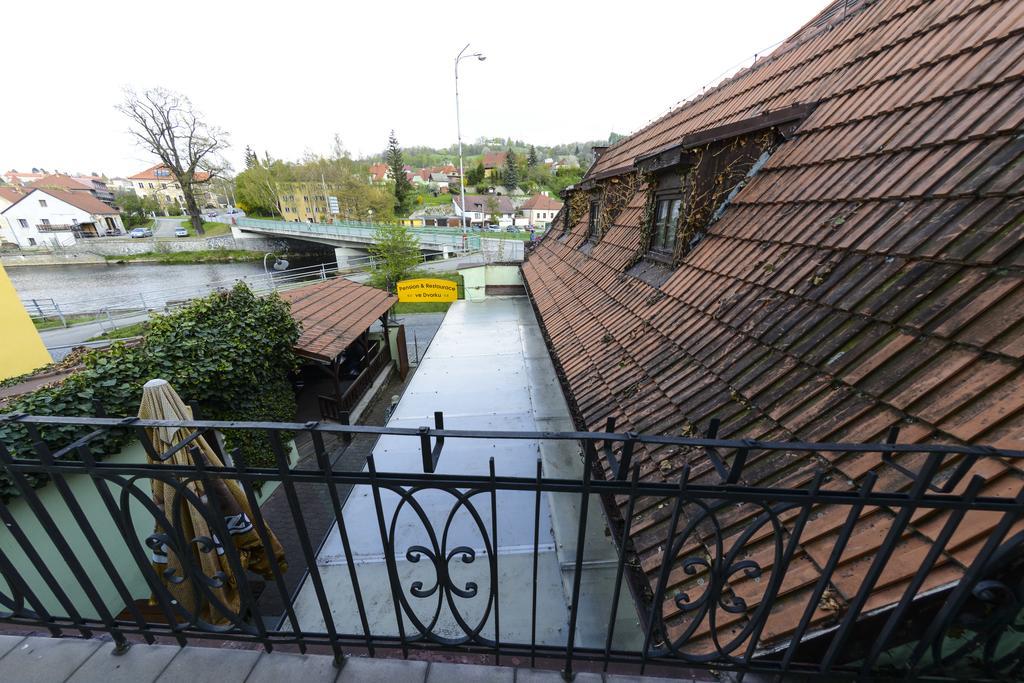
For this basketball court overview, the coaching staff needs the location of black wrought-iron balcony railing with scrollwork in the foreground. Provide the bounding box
[0,414,1024,680]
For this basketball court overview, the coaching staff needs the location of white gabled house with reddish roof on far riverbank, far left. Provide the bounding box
[0,187,125,248]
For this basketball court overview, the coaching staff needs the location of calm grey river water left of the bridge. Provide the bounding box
[7,257,323,313]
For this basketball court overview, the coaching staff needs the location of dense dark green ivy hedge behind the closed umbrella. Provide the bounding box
[0,283,299,500]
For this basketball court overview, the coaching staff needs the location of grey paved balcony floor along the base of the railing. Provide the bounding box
[0,636,692,683]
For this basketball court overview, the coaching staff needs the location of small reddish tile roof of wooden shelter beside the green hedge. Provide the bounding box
[281,278,398,362]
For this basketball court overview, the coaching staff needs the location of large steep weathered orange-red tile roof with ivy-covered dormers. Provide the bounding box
[523,0,1024,650]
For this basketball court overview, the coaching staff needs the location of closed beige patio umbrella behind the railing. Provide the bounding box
[138,379,288,624]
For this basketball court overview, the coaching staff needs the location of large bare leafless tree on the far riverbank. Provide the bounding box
[118,88,228,234]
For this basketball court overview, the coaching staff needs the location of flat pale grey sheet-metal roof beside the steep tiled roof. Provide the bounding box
[294,297,641,647]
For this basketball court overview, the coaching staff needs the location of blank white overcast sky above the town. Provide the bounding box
[0,0,826,176]
